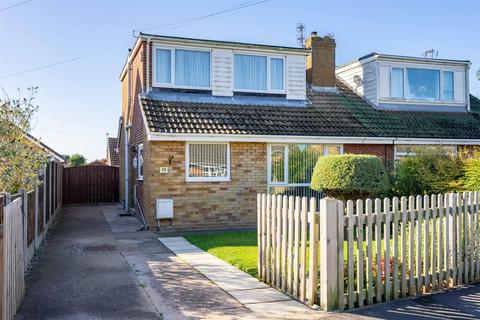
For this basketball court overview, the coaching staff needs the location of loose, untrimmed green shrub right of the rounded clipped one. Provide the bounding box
[393,150,462,196]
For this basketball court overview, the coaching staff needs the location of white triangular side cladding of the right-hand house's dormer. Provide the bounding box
[336,61,377,103]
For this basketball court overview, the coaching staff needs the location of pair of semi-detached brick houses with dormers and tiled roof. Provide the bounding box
[116,33,480,230]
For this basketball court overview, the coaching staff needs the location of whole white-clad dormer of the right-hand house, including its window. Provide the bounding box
[336,54,470,112]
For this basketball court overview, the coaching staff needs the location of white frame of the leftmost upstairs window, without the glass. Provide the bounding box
[152,45,213,90]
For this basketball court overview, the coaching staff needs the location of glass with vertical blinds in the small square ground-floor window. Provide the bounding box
[188,144,228,178]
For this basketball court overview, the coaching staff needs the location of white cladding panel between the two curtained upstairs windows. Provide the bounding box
[212,49,233,97]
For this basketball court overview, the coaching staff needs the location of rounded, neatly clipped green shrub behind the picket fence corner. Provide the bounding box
[311,154,388,200]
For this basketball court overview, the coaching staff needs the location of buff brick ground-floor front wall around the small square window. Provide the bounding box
[144,141,267,230]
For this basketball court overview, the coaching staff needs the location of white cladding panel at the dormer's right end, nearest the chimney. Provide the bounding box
[286,55,306,100]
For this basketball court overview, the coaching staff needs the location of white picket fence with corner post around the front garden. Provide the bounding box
[257,192,480,310]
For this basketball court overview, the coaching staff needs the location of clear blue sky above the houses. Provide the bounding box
[0,0,480,161]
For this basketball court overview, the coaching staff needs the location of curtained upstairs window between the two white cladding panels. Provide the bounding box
[234,54,285,92]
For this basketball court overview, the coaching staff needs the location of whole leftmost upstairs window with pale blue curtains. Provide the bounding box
[154,48,210,89]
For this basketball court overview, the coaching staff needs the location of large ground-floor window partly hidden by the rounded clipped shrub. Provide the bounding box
[267,144,343,197]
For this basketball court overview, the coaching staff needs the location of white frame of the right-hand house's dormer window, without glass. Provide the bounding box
[387,65,456,104]
